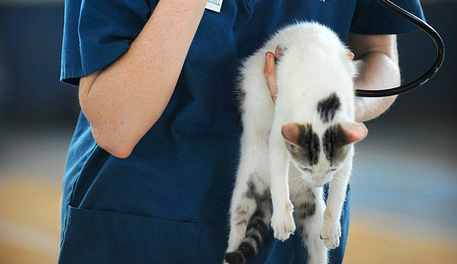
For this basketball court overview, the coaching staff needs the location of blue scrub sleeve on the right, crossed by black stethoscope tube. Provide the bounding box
[351,0,424,34]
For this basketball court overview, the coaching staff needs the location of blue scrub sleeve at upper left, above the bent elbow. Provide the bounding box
[60,0,151,85]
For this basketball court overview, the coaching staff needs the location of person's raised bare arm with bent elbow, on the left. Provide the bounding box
[80,0,206,157]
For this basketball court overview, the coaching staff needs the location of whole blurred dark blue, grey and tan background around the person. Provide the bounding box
[0,0,457,264]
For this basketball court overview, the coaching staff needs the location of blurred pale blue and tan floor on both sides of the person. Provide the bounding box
[0,123,457,264]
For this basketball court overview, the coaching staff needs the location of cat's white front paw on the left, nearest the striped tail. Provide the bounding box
[271,201,295,241]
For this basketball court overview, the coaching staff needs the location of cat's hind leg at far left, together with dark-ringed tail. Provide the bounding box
[225,127,272,264]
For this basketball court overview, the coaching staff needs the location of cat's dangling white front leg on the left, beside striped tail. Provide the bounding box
[269,134,295,241]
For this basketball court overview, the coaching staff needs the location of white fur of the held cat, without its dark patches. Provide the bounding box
[227,23,356,264]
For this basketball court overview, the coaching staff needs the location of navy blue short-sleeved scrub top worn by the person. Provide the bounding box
[59,0,422,264]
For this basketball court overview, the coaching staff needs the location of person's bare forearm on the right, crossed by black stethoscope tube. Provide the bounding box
[349,34,400,122]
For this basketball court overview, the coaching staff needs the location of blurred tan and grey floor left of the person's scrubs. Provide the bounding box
[0,127,71,264]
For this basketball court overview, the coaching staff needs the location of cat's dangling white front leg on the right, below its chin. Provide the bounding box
[321,153,352,249]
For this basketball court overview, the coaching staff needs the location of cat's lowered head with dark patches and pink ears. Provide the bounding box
[281,122,368,187]
